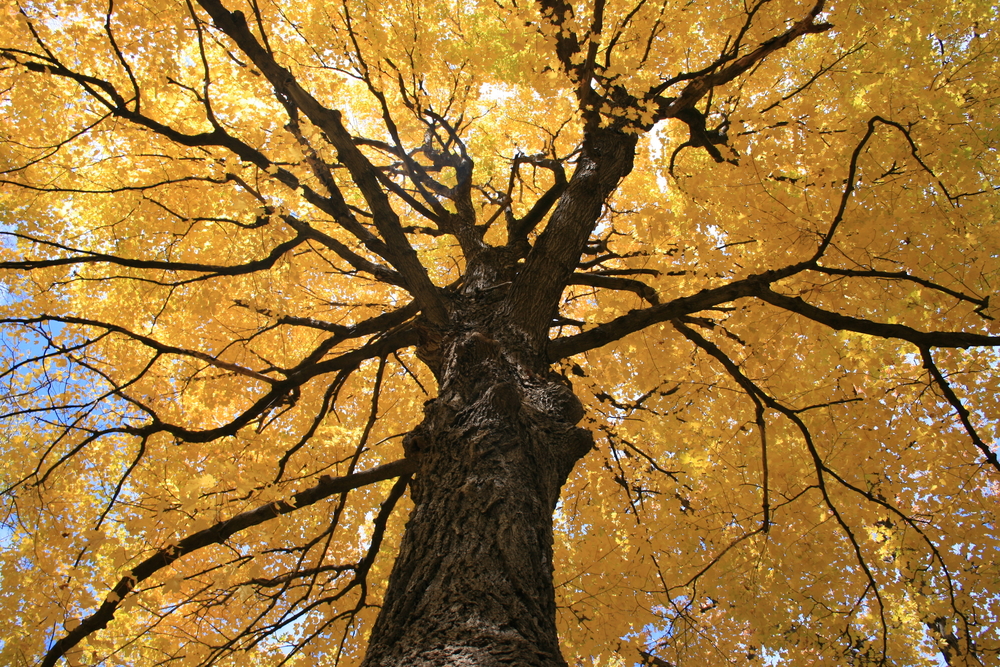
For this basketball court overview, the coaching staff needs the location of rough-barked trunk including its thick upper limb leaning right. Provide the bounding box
[363,126,636,667]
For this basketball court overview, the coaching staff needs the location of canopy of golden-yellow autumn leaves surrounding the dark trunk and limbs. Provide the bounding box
[0,1,1000,665]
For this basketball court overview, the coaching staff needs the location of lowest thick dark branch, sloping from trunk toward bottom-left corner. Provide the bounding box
[41,459,416,667]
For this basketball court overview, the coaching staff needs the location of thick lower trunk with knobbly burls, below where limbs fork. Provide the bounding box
[363,329,593,667]
